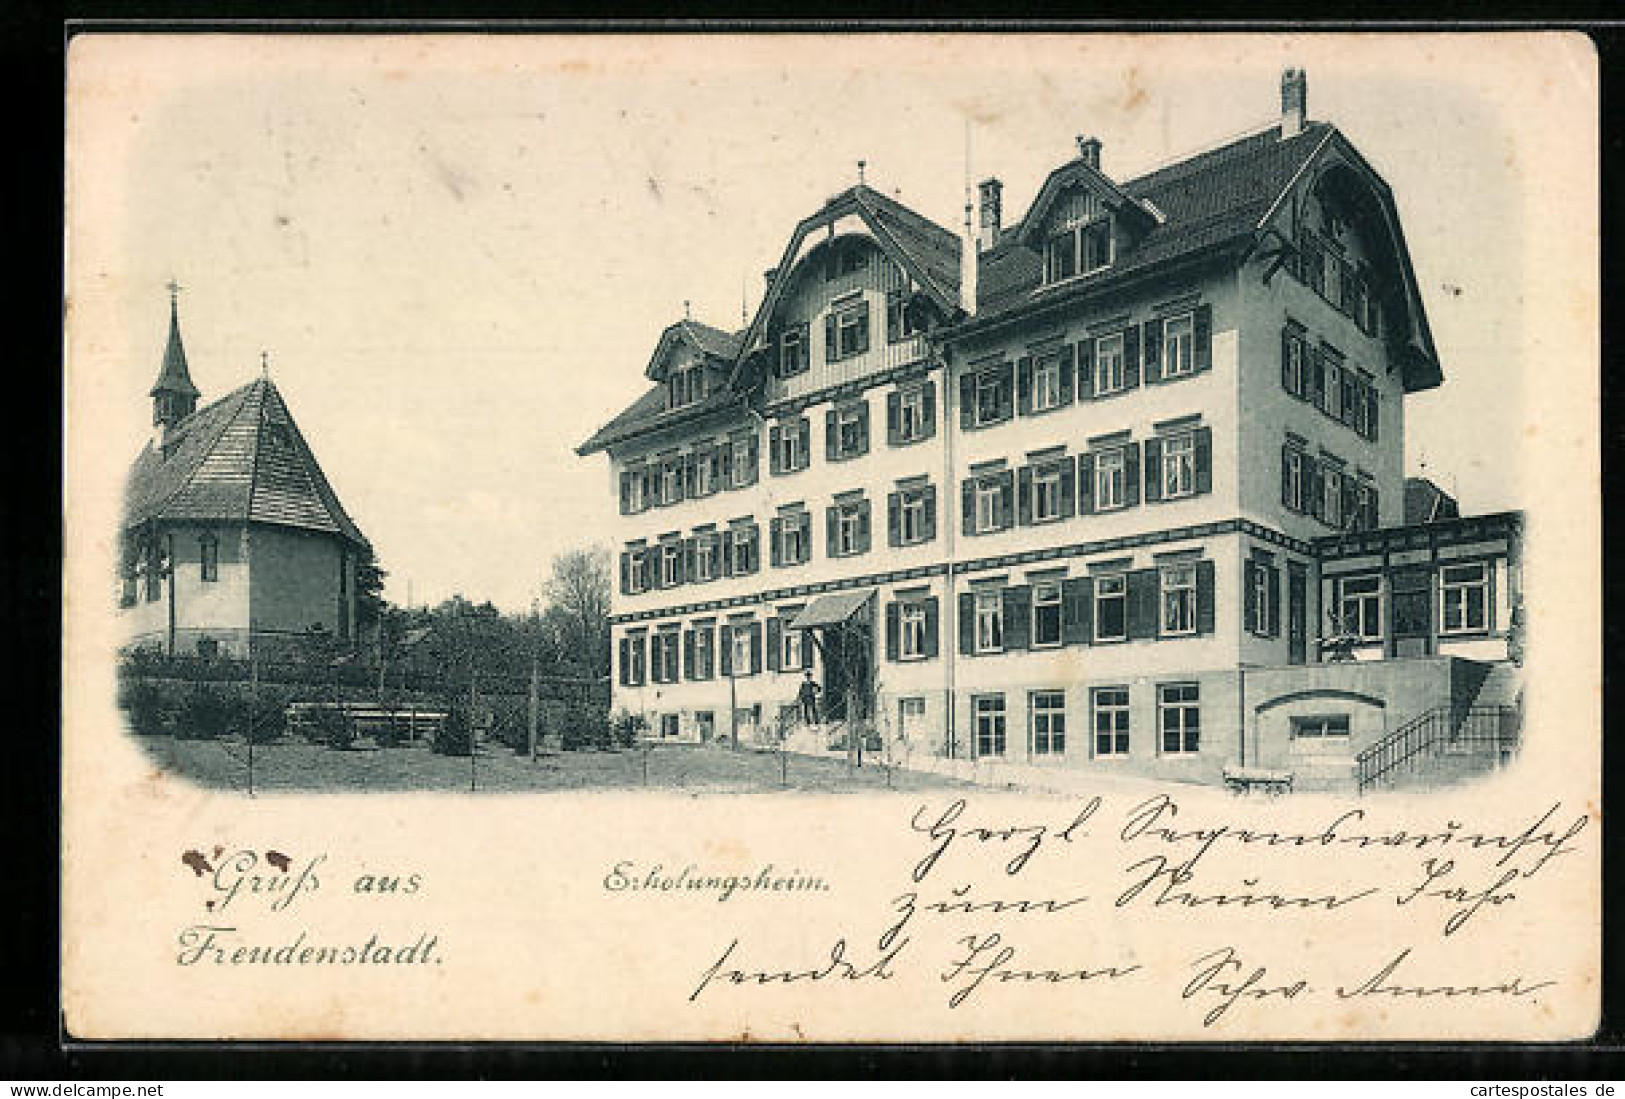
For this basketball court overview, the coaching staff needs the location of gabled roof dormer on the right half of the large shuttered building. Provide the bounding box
[1016,138,1157,286]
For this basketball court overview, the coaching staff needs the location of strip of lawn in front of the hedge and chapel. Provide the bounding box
[140,736,965,793]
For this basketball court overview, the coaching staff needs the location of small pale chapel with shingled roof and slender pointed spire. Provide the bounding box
[117,301,371,658]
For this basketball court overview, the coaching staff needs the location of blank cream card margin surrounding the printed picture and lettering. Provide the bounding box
[62,34,1601,1040]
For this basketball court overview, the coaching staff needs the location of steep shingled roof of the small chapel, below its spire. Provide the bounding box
[124,377,367,546]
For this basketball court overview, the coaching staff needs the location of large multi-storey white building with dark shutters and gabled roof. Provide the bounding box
[580,70,1518,785]
